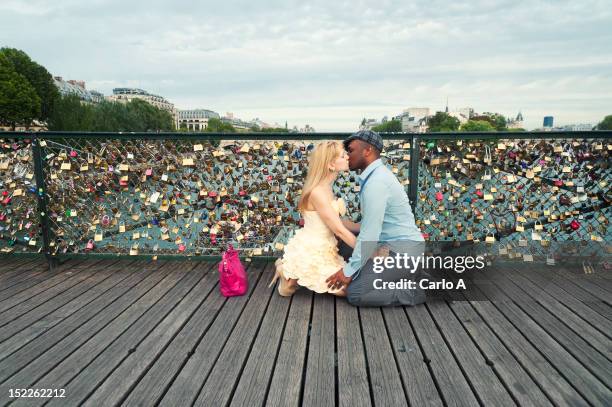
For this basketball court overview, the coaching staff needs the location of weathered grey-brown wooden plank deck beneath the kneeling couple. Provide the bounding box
[0,258,612,407]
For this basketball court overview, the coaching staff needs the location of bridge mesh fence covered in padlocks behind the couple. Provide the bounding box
[0,131,612,261]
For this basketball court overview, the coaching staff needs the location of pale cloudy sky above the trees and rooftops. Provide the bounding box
[0,0,612,131]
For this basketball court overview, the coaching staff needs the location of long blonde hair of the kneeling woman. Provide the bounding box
[298,141,343,213]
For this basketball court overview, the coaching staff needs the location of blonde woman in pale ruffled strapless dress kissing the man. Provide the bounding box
[270,141,357,296]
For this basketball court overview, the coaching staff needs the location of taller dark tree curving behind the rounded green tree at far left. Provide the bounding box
[0,48,60,121]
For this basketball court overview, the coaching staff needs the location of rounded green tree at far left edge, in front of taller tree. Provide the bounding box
[0,63,40,130]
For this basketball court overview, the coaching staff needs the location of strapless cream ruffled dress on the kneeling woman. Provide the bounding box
[276,198,346,293]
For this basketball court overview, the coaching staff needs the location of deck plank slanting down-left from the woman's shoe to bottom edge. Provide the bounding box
[195,263,274,406]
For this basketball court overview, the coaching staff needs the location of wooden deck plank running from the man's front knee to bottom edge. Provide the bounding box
[336,299,372,407]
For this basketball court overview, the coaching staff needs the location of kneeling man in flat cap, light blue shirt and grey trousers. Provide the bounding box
[326,130,425,306]
